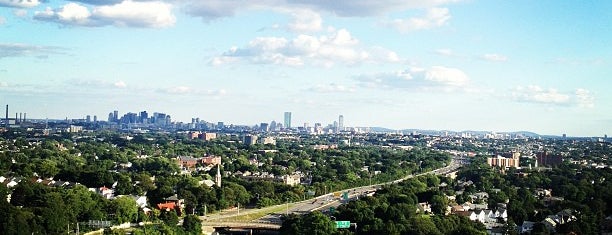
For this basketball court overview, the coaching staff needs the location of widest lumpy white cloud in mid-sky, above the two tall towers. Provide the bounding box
[211,29,399,67]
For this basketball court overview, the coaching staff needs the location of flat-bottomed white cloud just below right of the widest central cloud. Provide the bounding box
[354,66,470,91]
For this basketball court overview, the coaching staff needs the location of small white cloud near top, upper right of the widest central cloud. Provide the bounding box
[384,8,451,32]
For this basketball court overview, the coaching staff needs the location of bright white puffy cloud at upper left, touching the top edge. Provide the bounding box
[34,0,176,28]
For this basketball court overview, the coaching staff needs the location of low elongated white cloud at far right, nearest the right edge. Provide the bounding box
[511,85,595,108]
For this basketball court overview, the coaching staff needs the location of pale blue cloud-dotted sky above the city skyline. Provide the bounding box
[0,0,612,136]
